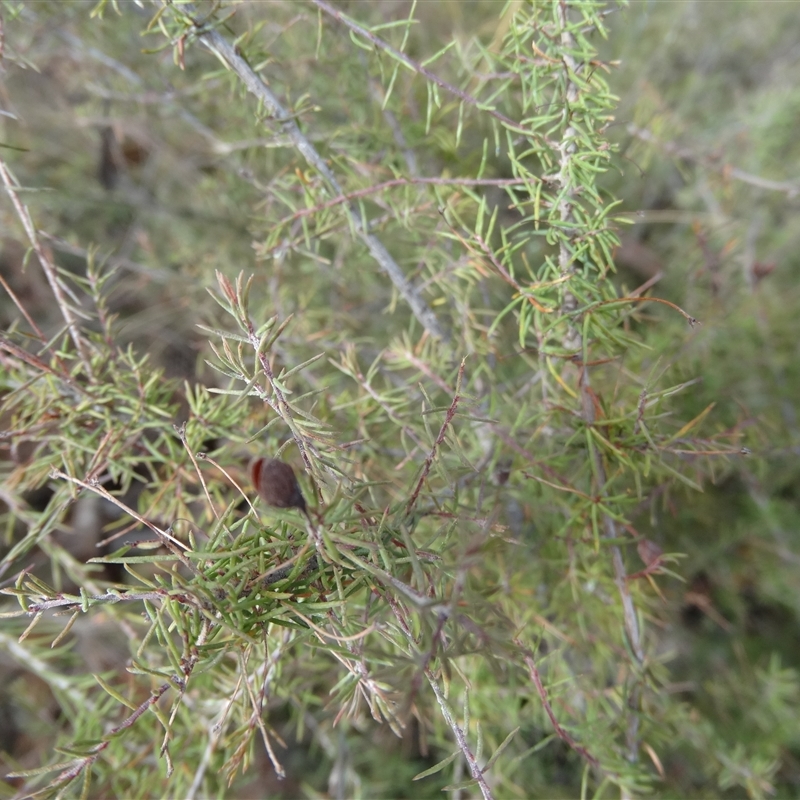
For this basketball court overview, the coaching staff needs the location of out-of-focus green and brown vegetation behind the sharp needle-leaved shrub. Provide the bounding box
[0,0,800,798]
